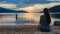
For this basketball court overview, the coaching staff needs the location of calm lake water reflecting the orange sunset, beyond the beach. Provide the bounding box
[0,13,60,25]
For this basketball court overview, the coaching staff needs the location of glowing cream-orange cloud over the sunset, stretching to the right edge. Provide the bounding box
[17,2,60,13]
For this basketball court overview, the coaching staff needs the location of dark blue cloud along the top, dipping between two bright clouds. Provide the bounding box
[0,0,59,8]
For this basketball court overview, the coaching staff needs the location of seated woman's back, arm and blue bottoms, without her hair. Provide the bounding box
[38,15,50,32]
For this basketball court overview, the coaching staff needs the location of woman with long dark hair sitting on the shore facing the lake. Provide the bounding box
[38,8,51,32]
